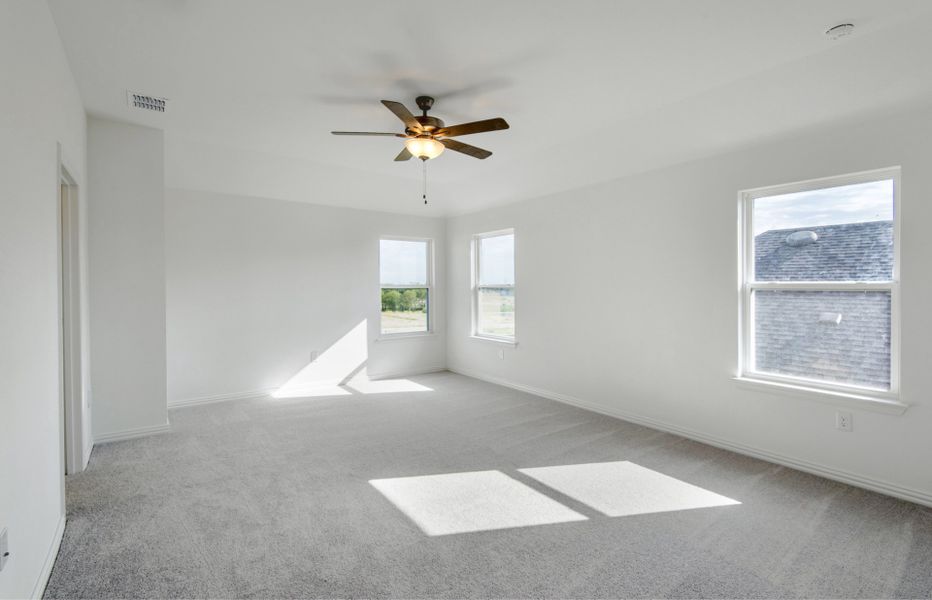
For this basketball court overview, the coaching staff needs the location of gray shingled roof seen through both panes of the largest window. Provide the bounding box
[754,221,893,389]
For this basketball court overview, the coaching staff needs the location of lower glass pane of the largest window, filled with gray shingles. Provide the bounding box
[753,290,890,389]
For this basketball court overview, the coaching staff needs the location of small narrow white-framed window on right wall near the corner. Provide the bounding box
[473,229,515,342]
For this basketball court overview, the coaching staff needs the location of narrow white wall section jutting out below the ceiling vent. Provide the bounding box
[87,118,167,441]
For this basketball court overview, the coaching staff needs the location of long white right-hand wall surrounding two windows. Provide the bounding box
[447,104,932,503]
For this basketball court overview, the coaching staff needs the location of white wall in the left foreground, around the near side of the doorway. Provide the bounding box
[0,0,85,598]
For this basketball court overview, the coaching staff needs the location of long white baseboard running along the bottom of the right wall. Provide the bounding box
[447,367,932,507]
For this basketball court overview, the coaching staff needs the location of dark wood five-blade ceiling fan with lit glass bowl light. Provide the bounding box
[331,96,508,161]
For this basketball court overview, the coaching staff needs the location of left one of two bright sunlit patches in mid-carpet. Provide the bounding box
[369,471,586,536]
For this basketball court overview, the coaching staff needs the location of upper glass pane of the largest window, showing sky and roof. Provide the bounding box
[752,179,893,281]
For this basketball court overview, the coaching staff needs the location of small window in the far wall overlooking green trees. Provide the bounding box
[379,238,432,335]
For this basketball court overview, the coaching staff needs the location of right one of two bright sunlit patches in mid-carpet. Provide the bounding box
[518,461,741,517]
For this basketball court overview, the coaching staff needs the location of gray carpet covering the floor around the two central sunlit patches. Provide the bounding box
[46,373,932,598]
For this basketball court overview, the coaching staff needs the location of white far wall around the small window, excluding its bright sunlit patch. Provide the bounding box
[165,189,446,404]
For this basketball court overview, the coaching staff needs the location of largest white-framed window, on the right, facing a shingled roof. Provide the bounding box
[740,169,899,400]
